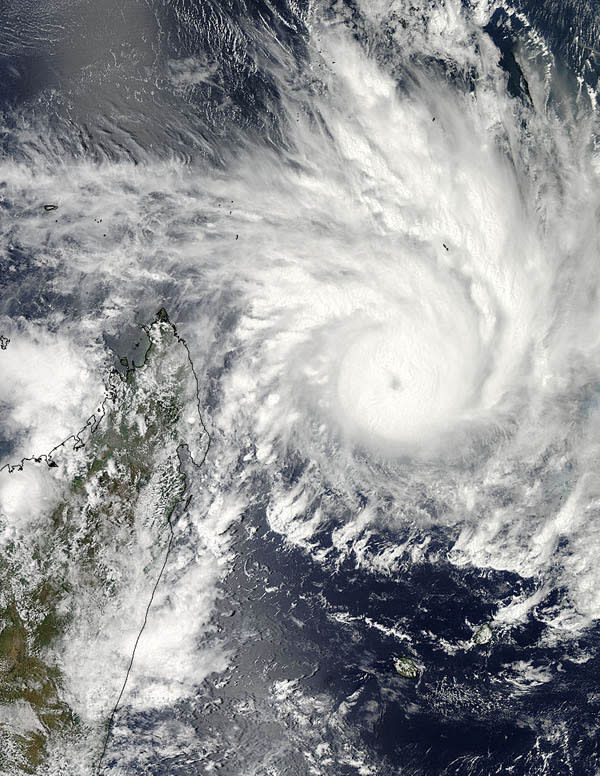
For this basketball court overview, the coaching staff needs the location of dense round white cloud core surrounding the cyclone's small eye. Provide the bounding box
[336,311,478,448]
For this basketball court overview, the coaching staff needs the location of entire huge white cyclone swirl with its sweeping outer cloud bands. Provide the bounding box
[3,3,600,636]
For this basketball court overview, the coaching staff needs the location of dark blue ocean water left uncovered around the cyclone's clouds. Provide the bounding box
[0,0,600,776]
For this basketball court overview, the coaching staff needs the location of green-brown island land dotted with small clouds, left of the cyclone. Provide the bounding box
[0,311,207,774]
